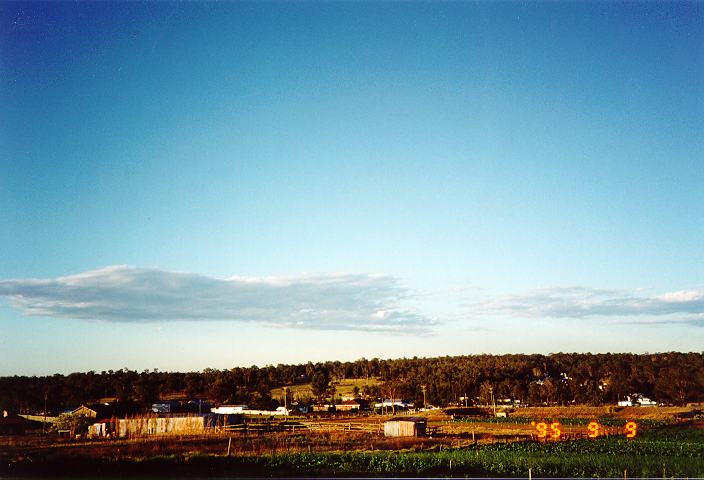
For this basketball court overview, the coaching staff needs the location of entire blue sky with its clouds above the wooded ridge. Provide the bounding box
[0,2,704,374]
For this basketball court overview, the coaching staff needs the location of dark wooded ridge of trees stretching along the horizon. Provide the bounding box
[0,352,704,412]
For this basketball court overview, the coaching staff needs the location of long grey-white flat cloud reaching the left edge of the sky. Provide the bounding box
[0,266,435,334]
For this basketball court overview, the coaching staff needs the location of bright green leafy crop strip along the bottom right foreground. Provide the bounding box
[204,439,704,477]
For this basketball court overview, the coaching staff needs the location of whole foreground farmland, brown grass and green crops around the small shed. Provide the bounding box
[0,409,704,478]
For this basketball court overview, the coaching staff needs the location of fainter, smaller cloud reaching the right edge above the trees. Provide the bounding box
[467,287,704,326]
